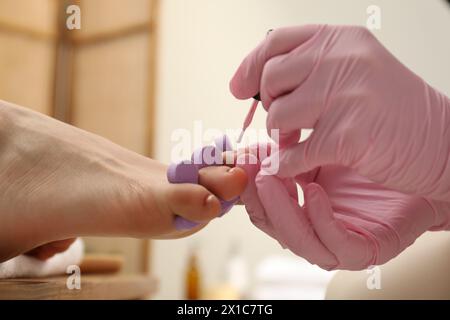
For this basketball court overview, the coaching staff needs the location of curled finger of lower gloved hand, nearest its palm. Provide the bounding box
[304,183,377,270]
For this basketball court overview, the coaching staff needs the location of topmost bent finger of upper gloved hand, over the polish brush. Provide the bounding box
[230,25,322,99]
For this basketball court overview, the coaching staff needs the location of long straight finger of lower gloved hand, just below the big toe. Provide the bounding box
[256,174,338,270]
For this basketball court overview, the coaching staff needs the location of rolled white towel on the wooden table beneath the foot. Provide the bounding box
[0,238,84,279]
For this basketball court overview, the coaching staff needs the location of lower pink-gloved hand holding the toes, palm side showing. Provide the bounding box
[238,146,450,270]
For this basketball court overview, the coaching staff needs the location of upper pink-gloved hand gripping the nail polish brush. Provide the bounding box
[230,25,450,200]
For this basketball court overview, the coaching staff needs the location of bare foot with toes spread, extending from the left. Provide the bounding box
[0,101,246,262]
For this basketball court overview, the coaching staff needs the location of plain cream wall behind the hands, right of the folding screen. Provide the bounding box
[152,0,450,298]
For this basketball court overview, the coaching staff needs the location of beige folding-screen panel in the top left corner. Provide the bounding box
[0,0,56,34]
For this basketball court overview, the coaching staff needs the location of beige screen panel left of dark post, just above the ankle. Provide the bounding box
[0,29,55,114]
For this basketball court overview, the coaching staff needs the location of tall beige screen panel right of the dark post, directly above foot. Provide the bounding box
[71,34,149,154]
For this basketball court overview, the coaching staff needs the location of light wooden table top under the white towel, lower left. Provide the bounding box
[0,275,156,300]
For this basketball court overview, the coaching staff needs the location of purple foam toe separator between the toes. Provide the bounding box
[167,135,239,230]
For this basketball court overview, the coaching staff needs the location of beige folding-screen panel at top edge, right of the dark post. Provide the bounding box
[75,0,151,39]
